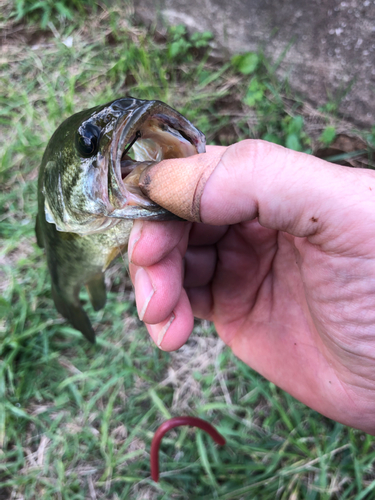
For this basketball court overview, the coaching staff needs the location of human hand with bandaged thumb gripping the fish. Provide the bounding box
[129,140,375,434]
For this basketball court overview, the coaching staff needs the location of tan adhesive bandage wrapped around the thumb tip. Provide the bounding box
[139,147,226,222]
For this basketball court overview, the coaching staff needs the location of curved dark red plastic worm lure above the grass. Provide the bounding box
[150,417,225,482]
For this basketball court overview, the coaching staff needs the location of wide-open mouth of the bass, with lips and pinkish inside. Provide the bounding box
[108,101,205,220]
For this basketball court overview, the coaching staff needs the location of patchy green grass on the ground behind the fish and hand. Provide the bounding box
[0,2,375,500]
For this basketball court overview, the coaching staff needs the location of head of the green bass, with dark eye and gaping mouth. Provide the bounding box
[39,97,205,235]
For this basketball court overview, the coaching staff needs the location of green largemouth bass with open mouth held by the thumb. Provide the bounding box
[36,97,205,342]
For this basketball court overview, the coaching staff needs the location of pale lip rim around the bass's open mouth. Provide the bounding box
[108,100,206,219]
